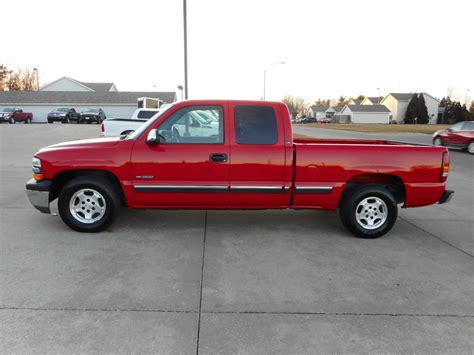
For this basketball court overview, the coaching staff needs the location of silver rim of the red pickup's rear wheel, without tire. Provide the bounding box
[355,197,388,230]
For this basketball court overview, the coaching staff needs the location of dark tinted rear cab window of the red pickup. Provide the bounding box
[234,105,278,145]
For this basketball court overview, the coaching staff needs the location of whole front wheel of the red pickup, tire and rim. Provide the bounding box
[58,176,120,233]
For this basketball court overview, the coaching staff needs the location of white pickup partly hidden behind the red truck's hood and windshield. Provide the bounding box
[100,105,165,137]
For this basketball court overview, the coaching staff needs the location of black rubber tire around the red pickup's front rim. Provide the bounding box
[58,175,120,233]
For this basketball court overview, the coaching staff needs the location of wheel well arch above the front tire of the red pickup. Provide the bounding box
[50,169,127,206]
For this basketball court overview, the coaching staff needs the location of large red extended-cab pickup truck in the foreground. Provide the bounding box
[26,100,453,238]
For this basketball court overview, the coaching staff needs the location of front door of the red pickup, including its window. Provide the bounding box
[132,103,230,208]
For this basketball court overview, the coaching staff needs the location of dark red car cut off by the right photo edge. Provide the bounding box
[433,121,474,154]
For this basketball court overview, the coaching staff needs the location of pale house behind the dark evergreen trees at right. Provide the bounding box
[381,92,439,124]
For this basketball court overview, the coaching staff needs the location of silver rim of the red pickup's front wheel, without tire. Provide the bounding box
[69,189,107,224]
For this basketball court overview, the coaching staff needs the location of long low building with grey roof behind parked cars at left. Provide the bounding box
[0,78,177,122]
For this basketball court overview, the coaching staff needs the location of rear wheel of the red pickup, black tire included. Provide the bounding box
[339,184,398,239]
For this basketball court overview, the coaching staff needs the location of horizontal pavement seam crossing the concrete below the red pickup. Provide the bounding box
[0,307,474,318]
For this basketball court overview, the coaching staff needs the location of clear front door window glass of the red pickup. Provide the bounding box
[158,106,224,144]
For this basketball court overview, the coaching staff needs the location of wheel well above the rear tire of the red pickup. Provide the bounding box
[339,174,406,204]
